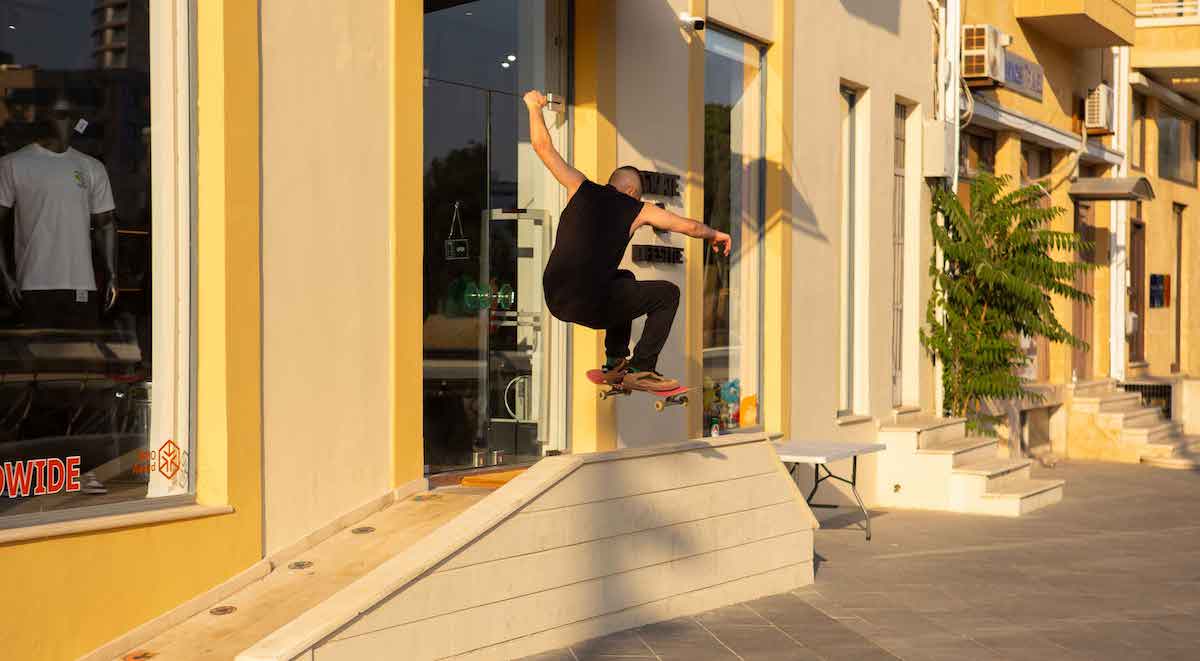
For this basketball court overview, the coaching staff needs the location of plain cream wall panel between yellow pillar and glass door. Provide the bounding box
[262,0,393,554]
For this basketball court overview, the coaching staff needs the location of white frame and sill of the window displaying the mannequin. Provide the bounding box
[0,0,197,530]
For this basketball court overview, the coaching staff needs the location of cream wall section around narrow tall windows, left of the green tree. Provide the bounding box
[787,0,936,429]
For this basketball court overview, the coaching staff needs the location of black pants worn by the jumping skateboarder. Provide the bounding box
[583,270,679,369]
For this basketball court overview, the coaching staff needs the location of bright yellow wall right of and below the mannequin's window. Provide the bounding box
[0,0,262,660]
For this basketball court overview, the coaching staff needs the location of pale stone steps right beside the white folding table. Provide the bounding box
[874,416,1063,516]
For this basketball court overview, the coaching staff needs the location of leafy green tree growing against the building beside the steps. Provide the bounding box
[920,173,1093,433]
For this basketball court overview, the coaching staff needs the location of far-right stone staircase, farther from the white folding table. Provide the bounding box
[1066,379,1200,469]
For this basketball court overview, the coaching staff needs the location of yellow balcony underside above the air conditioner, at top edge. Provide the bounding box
[1014,0,1132,48]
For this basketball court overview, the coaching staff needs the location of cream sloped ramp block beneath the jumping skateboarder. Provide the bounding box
[238,434,817,661]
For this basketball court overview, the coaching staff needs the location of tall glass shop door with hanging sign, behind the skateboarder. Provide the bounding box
[422,0,566,473]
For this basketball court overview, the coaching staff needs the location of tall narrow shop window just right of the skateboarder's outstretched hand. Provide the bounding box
[703,30,763,429]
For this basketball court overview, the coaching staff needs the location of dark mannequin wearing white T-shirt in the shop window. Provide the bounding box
[0,100,118,329]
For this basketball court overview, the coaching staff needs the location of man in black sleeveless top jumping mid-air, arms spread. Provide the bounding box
[524,90,732,390]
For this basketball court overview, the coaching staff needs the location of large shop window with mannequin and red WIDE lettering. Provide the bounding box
[0,0,191,527]
